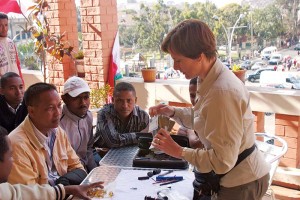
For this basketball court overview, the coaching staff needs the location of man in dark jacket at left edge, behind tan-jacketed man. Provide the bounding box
[0,72,27,133]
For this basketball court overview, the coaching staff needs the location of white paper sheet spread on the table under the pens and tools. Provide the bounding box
[112,169,194,200]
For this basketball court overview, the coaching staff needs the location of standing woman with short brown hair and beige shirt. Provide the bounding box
[150,19,270,200]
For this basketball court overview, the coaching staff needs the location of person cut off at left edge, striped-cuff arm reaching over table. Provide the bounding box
[0,126,102,200]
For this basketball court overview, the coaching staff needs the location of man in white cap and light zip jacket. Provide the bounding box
[60,76,97,172]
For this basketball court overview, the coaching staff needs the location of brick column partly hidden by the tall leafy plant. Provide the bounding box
[47,0,78,92]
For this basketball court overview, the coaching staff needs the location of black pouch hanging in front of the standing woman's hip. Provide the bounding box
[193,171,221,200]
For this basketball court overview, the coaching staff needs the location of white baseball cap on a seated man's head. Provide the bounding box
[63,76,91,97]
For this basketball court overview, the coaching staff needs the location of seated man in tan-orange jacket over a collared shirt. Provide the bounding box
[8,83,86,185]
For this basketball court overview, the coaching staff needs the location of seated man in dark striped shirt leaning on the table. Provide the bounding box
[95,82,149,148]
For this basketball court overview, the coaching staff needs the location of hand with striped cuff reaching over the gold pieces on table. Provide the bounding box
[64,182,103,200]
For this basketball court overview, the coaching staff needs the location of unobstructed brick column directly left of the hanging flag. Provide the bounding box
[80,0,118,88]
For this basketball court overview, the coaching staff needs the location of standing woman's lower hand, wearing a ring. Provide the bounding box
[152,129,183,158]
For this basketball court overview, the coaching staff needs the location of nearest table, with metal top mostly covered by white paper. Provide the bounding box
[82,165,194,200]
